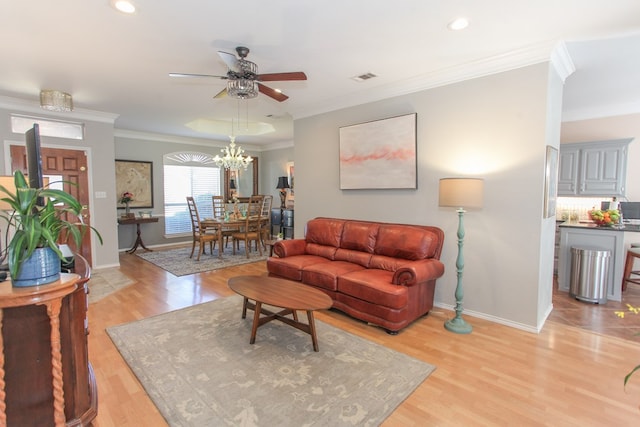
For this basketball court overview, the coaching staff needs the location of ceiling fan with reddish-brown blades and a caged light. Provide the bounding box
[169,46,307,102]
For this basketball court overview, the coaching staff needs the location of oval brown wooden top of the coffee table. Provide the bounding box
[228,276,333,311]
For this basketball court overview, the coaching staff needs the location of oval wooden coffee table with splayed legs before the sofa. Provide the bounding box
[228,276,333,351]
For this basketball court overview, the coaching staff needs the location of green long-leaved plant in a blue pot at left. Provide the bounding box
[0,171,102,286]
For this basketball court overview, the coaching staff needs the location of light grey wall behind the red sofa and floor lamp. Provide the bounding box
[294,64,560,330]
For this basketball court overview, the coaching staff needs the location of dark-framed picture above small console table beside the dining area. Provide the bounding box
[116,159,153,209]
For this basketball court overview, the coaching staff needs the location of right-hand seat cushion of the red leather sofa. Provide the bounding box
[338,268,408,309]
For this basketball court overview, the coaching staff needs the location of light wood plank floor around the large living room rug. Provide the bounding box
[89,254,640,427]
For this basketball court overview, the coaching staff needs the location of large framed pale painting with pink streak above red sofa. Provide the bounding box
[340,113,418,190]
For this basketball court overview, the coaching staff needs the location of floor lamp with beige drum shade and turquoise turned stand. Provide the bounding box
[439,178,483,334]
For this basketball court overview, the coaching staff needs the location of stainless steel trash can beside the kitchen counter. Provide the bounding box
[569,247,611,304]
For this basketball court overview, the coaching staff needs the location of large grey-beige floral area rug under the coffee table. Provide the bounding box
[107,296,435,427]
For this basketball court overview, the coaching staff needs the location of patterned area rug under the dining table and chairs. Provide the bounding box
[136,246,267,276]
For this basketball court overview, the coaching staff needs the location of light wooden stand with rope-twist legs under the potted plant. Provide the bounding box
[0,273,80,427]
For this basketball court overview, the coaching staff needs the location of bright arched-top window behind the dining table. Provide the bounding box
[164,153,222,236]
